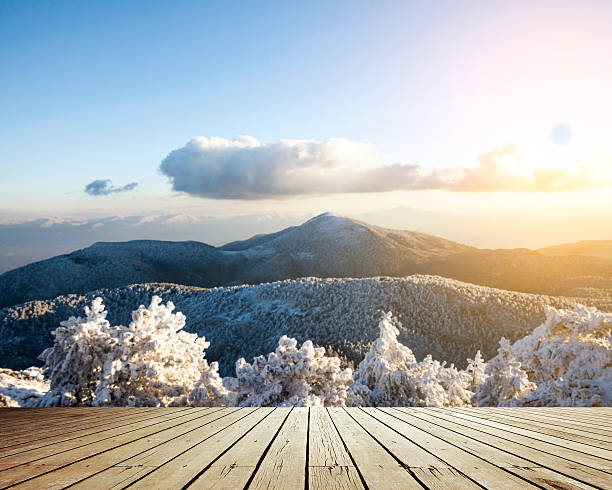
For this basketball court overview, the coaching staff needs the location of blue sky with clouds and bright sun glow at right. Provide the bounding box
[0,0,612,258]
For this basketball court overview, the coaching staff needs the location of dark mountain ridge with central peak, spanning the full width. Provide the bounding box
[0,213,612,307]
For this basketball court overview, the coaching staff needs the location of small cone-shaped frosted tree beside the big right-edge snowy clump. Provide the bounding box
[473,337,536,407]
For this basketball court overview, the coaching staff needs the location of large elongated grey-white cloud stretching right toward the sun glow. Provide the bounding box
[160,136,599,199]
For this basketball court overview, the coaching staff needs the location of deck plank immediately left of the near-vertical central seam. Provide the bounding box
[250,407,308,490]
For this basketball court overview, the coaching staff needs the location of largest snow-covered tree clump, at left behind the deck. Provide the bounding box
[36,296,217,406]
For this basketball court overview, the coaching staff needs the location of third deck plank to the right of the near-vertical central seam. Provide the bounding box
[347,408,480,490]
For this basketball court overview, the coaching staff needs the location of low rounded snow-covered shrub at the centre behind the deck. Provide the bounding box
[224,335,352,407]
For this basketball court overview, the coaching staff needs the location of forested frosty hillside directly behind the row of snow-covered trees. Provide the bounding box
[0,275,612,375]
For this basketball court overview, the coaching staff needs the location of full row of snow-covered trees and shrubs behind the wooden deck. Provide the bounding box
[0,296,612,407]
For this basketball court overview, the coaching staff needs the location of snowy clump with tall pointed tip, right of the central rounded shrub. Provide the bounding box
[351,313,481,406]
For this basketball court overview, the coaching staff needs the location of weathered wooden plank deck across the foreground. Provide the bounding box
[0,408,612,490]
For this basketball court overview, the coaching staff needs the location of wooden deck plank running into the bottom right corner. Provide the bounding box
[416,410,610,487]
